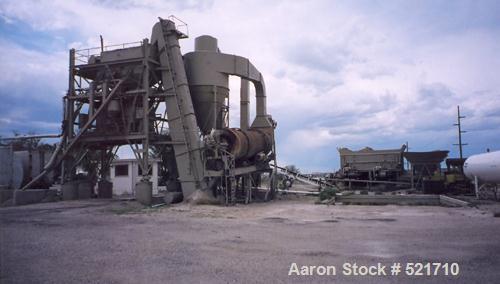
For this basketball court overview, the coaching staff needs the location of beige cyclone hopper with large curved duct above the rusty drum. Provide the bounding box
[184,35,273,134]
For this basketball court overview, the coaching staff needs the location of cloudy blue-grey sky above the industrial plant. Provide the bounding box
[0,0,500,171]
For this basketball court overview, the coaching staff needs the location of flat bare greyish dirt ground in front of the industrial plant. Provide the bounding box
[0,197,500,283]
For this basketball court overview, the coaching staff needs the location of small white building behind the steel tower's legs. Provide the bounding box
[110,159,165,195]
